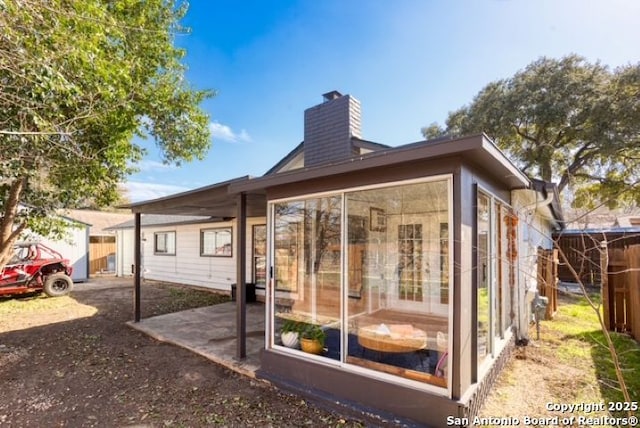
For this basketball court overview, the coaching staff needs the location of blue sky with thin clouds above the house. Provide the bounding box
[126,0,640,201]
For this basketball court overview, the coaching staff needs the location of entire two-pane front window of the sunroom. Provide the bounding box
[272,178,452,387]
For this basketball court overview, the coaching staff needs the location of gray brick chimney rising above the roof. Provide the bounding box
[304,91,361,167]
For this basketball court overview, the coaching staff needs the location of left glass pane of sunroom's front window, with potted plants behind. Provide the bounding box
[274,196,342,360]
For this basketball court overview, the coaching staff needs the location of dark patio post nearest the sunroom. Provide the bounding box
[236,193,247,359]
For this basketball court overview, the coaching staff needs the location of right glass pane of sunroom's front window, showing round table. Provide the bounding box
[345,180,450,387]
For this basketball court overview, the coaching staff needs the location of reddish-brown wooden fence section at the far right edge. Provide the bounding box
[602,245,640,341]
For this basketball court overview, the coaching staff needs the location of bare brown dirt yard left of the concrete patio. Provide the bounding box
[0,279,362,427]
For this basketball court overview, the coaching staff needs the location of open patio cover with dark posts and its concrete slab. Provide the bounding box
[128,176,267,374]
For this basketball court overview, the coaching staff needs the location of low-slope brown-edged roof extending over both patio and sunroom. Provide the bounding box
[129,134,531,217]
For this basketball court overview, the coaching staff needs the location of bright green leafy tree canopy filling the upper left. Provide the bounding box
[0,0,213,266]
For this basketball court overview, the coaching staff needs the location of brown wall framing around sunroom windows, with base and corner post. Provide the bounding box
[261,158,513,425]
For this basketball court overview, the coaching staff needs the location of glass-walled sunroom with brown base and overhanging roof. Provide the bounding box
[230,135,529,425]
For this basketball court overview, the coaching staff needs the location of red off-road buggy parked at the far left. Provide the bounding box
[0,242,73,297]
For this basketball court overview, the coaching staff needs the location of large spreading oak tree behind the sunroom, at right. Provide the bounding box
[422,55,640,207]
